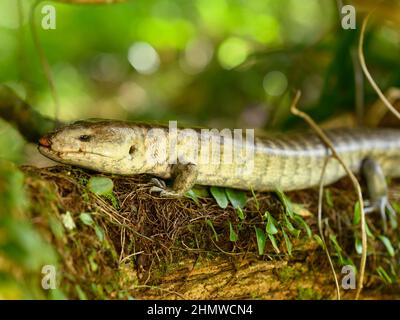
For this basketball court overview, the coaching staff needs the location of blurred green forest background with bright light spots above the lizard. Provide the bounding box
[0,0,400,161]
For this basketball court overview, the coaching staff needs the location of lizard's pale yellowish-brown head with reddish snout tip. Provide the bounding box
[38,120,147,173]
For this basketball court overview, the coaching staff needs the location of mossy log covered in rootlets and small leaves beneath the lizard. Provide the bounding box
[13,166,400,299]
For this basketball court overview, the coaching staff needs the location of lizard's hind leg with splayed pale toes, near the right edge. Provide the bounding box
[361,158,396,232]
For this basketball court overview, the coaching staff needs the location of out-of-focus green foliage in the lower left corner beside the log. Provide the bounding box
[0,160,57,299]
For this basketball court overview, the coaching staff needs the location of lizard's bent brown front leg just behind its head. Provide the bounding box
[150,163,198,197]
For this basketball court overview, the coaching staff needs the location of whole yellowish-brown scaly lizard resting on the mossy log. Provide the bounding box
[38,120,400,229]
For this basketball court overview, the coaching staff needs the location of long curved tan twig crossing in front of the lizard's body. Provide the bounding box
[290,91,368,300]
